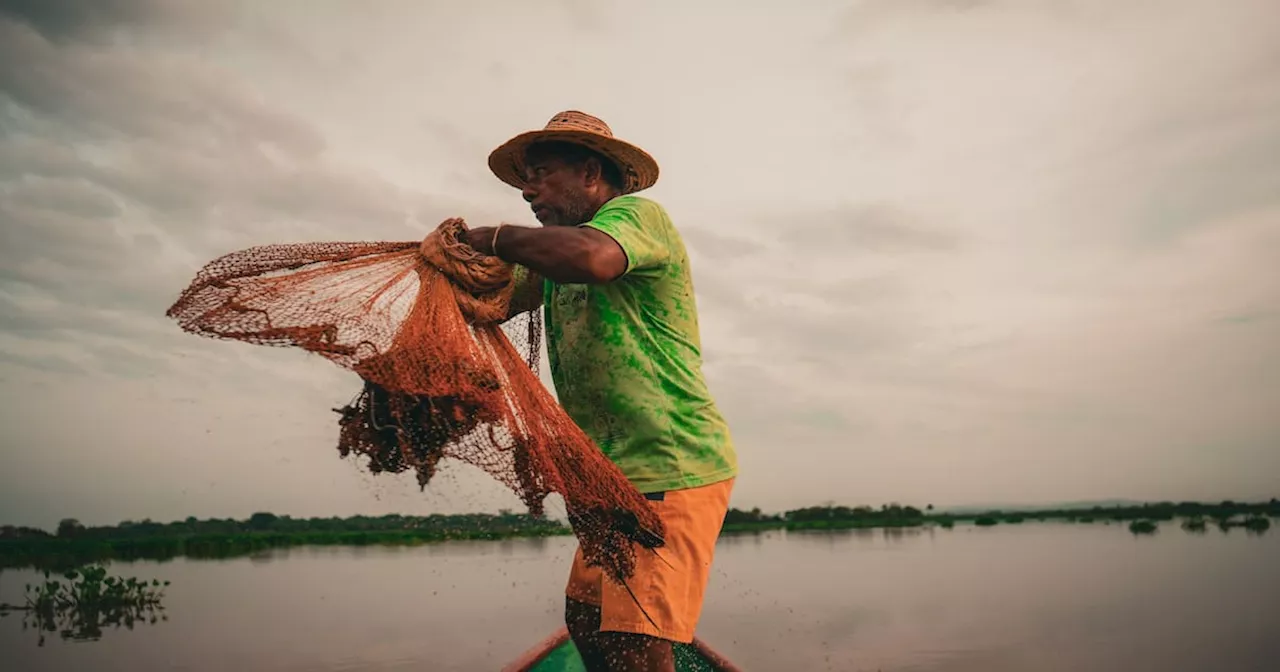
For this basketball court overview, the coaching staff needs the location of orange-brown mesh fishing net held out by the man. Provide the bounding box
[168,219,663,581]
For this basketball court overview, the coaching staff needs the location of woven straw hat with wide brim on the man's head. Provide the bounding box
[489,110,658,193]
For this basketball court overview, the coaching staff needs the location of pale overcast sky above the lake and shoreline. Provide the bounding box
[0,0,1280,527]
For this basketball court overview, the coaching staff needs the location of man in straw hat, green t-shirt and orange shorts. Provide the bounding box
[467,111,737,671]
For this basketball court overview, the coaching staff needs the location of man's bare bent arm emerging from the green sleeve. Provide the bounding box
[486,225,626,284]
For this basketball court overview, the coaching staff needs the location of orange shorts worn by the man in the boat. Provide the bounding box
[564,479,733,644]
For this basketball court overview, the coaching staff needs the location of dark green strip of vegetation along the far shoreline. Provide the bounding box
[0,499,1280,570]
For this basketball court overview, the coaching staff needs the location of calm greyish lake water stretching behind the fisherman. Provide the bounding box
[0,524,1280,672]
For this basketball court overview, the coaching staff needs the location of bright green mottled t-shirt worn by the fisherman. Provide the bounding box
[527,196,737,493]
